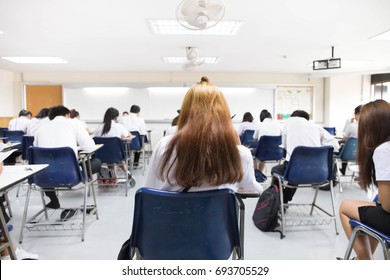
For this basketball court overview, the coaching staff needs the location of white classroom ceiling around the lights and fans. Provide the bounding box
[0,0,390,76]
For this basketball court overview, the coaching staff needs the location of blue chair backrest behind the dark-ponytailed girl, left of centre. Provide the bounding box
[93,136,125,164]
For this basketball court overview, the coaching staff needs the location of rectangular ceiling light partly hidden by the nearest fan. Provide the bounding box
[149,19,242,35]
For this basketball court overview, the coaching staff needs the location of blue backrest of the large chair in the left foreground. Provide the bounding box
[27,146,84,188]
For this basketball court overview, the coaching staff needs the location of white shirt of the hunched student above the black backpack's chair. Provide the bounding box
[282,117,339,161]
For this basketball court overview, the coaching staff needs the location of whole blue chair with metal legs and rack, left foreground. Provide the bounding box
[19,147,99,243]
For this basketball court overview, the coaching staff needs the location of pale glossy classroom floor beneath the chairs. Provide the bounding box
[3,164,382,260]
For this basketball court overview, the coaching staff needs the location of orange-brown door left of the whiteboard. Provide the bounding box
[26,85,62,116]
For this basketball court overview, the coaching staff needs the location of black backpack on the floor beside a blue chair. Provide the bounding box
[252,185,281,237]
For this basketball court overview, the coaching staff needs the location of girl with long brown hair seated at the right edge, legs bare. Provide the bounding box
[340,100,390,260]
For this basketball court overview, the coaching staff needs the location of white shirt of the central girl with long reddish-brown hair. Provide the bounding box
[144,135,263,193]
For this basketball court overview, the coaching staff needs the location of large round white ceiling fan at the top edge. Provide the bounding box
[176,0,225,30]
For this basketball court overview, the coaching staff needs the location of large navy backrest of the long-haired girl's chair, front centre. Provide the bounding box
[131,188,241,260]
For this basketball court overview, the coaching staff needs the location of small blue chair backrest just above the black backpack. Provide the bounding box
[255,135,285,162]
